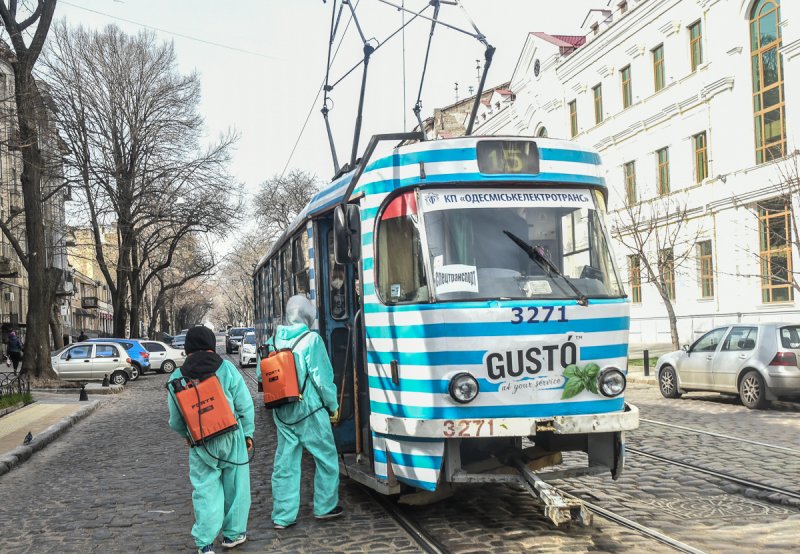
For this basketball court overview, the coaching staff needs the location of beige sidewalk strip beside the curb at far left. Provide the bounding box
[0,387,108,475]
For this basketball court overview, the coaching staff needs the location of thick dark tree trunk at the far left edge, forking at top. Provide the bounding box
[0,0,62,377]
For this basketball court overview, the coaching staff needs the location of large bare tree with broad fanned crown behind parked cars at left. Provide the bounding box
[44,23,241,336]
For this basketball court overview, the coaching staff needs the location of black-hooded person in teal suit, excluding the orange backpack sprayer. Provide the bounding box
[167,327,255,554]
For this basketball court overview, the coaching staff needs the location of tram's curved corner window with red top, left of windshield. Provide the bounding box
[375,192,429,304]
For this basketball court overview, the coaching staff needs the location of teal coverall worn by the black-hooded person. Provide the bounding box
[168,360,255,547]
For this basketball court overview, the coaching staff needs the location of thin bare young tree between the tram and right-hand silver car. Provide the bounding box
[612,196,701,350]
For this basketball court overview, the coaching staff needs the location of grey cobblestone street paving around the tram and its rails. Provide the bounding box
[0,356,800,553]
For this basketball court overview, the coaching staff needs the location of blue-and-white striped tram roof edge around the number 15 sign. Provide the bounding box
[255,135,606,271]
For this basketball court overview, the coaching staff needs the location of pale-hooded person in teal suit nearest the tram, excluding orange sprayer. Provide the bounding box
[259,295,343,529]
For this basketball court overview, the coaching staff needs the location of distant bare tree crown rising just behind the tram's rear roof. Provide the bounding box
[255,169,319,243]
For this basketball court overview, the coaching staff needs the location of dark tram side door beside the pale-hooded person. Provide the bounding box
[315,216,356,452]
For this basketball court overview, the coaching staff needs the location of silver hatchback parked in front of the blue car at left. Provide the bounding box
[50,341,138,385]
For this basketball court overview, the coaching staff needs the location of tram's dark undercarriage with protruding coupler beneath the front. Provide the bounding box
[339,404,639,525]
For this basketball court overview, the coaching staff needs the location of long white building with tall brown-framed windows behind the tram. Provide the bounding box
[475,0,800,343]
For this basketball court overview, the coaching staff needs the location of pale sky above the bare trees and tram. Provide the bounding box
[56,0,606,193]
